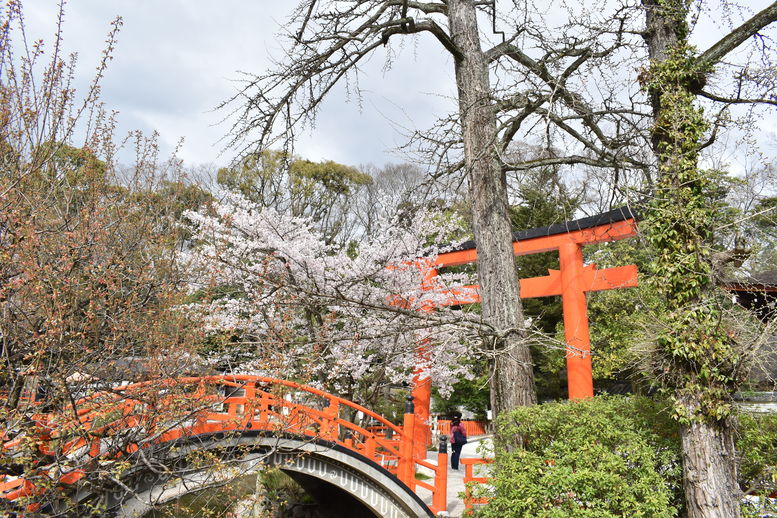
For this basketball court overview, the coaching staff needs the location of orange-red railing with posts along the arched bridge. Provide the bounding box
[0,375,447,514]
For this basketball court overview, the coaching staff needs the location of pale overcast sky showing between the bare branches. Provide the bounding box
[25,0,774,174]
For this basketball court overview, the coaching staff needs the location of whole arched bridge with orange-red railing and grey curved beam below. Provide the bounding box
[0,375,447,518]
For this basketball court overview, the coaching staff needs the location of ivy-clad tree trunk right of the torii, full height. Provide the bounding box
[643,0,741,518]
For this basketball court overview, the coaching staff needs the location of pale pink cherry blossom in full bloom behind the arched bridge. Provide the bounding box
[185,194,481,394]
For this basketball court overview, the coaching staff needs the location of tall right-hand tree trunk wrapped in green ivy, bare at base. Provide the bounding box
[643,0,741,518]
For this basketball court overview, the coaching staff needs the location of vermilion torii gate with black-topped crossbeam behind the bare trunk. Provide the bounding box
[413,207,637,456]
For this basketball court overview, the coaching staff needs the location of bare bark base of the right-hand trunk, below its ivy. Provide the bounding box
[680,398,741,518]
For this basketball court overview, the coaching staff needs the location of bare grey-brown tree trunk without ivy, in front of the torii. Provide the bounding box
[448,0,536,415]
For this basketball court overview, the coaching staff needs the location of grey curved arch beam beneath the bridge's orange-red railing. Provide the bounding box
[82,431,433,518]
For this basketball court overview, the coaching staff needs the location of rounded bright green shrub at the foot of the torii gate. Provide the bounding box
[477,397,682,518]
